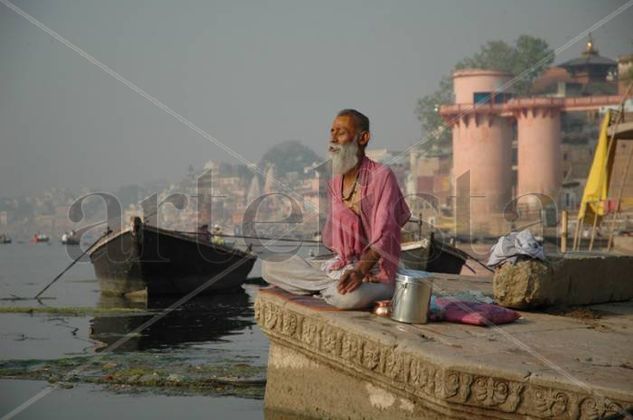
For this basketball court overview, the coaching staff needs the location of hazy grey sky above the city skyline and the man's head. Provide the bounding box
[0,0,633,196]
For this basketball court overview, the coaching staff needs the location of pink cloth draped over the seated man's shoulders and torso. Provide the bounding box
[322,157,411,284]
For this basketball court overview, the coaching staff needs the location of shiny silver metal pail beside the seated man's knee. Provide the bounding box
[391,274,431,324]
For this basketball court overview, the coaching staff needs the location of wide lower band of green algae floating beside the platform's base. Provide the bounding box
[0,353,266,398]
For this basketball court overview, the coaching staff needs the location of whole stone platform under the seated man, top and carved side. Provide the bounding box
[255,276,633,419]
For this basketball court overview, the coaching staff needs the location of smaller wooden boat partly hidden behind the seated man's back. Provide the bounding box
[400,233,468,274]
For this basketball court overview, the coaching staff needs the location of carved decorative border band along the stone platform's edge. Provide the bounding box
[255,293,633,419]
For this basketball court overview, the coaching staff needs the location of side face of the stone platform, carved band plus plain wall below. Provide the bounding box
[255,293,633,419]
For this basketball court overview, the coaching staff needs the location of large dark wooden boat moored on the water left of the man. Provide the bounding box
[89,217,257,296]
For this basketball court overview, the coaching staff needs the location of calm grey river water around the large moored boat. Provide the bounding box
[0,243,276,419]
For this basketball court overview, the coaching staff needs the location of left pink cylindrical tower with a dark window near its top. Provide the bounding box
[441,69,512,232]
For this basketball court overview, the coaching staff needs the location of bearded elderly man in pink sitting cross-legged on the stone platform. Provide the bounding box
[262,109,411,309]
